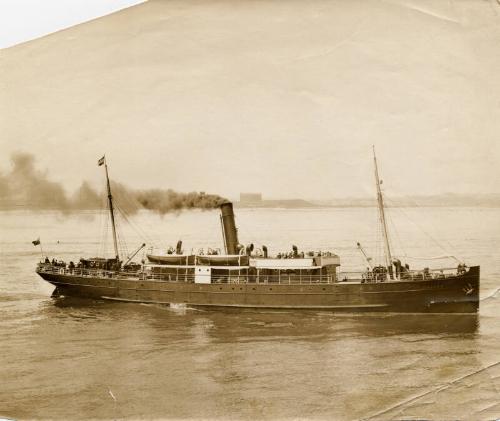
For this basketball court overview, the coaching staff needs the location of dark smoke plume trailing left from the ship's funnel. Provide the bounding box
[0,152,227,214]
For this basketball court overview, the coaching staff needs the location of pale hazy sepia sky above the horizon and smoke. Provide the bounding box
[0,0,500,199]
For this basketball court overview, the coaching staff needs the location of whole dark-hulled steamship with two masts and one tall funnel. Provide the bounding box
[36,150,479,313]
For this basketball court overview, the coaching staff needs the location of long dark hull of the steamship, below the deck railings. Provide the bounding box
[39,266,479,313]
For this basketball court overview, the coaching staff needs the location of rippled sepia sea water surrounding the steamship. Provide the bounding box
[0,208,500,420]
